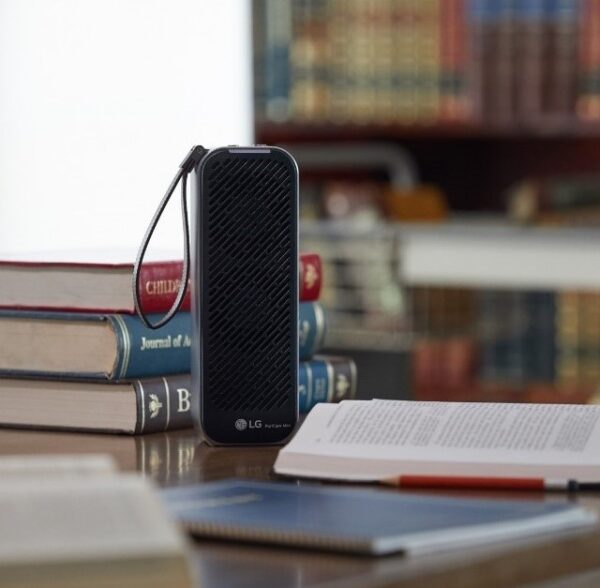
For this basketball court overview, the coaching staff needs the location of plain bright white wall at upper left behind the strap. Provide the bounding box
[0,0,252,251]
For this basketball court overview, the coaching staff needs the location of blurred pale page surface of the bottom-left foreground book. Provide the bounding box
[0,474,184,567]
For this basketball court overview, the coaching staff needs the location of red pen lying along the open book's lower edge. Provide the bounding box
[380,475,600,492]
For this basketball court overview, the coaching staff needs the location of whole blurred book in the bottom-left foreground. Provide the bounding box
[0,456,193,588]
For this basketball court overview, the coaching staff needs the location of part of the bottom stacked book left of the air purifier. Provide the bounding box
[0,374,193,435]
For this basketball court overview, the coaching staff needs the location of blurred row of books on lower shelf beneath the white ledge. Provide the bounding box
[410,278,600,403]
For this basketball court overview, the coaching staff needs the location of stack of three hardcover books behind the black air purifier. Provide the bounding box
[0,252,355,434]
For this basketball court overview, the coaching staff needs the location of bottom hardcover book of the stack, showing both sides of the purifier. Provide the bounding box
[0,356,357,435]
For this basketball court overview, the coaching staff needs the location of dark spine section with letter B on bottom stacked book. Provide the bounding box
[133,374,193,435]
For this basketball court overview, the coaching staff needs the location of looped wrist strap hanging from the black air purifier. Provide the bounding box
[133,145,208,329]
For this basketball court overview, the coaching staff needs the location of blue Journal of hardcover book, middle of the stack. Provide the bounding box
[0,302,326,380]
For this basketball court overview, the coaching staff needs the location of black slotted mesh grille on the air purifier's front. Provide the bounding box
[202,157,298,412]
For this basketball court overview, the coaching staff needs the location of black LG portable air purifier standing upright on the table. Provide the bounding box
[191,146,298,445]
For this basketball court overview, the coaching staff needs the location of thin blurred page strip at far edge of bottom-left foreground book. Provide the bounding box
[0,454,117,484]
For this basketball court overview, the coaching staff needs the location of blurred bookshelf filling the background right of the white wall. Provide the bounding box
[253,0,600,402]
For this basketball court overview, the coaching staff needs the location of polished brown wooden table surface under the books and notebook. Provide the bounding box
[0,429,600,588]
